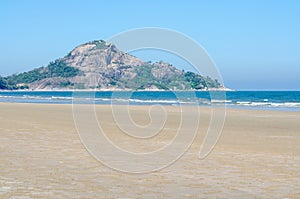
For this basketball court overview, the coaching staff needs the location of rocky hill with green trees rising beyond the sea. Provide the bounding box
[0,40,222,90]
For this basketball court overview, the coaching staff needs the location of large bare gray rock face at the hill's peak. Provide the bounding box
[62,40,145,89]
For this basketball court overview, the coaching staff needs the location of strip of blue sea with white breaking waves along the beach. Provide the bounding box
[0,91,300,111]
